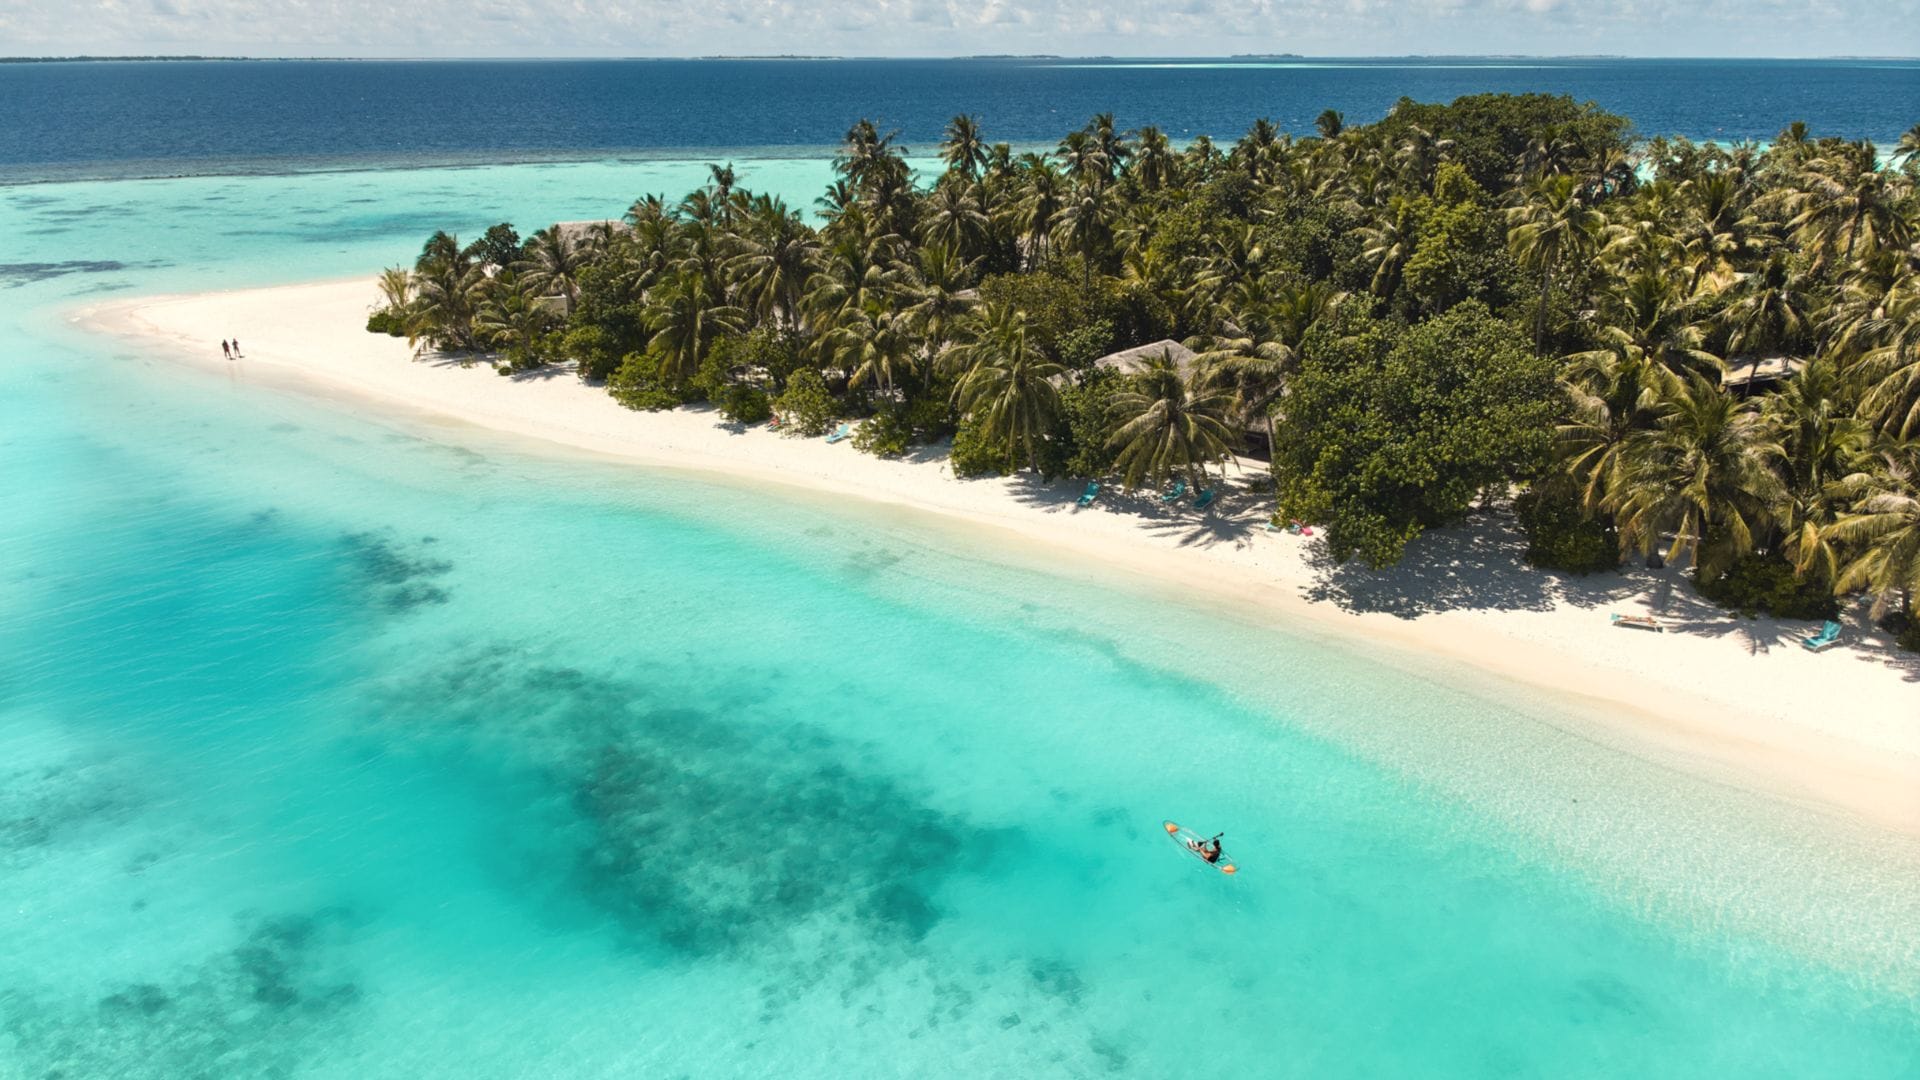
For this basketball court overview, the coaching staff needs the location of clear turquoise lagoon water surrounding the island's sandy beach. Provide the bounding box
[0,161,1920,1078]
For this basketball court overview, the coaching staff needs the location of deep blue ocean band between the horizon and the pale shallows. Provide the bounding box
[0,58,1920,181]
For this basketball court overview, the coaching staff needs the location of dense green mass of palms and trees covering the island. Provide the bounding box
[369,94,1920,642]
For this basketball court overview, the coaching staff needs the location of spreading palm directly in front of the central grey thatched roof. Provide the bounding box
[1108,357,1235,488]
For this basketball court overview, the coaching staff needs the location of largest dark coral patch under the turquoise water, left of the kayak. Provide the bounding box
[368,648,1010,957]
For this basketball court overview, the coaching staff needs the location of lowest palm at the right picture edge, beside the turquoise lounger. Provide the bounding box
[1822,442,1920,621]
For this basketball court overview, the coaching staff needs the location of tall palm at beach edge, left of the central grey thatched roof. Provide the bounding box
[954,304,1066,473]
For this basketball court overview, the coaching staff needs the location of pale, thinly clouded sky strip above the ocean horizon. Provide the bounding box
[0,0,1920,56]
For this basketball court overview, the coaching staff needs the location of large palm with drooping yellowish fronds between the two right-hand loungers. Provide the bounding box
[1603,375,1786,573]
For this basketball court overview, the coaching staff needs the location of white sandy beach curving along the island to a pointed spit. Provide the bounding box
[75,281,1920,834]
